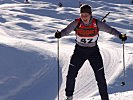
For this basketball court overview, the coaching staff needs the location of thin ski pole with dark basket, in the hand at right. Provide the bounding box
[121,34,126,86]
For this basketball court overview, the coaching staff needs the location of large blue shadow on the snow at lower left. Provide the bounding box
[0,45,62,100]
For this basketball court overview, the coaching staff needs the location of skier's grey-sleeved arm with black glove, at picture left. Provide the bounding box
[55,21,78,38]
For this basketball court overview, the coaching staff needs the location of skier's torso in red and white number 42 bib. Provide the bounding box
[75,18,99,46]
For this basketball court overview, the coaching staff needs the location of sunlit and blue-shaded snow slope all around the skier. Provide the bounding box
[0,0,133,100]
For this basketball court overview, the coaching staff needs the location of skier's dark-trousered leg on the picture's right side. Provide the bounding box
[88,50,109,100]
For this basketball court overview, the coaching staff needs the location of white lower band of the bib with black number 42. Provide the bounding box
[76,35,98,44]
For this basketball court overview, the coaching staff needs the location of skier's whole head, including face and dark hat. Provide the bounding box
[80,4,92,24]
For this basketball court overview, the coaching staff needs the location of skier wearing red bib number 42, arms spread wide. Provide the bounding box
[55,4,127,100]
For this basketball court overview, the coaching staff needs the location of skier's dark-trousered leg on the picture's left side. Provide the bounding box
[65,52,86,96]
